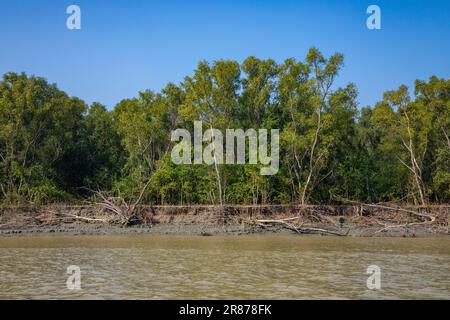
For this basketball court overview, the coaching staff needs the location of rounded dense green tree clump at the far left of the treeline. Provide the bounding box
[0,73,87,202]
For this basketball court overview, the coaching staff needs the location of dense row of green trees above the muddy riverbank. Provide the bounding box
[0,48,450,204]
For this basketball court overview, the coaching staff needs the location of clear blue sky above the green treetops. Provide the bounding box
[0,0,450,108]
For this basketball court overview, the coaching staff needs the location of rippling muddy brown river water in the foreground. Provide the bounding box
[0,236,450,299]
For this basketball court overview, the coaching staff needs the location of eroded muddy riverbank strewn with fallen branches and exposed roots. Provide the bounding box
[0,205,450,237]
